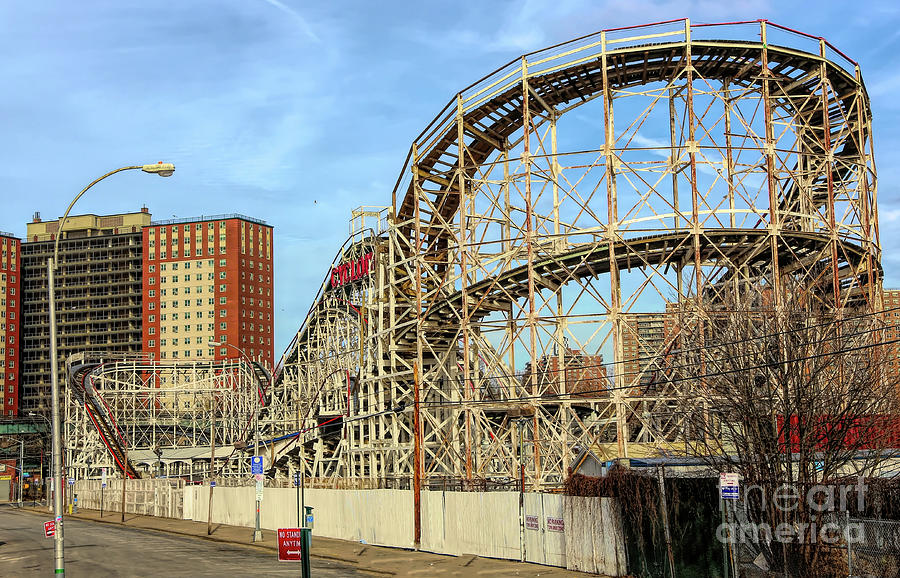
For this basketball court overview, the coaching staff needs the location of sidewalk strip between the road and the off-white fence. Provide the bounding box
[23,506,588,578]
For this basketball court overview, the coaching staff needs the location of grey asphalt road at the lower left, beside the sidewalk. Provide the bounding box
[0,507,360,578]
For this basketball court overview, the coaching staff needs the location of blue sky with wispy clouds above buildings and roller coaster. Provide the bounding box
[0,0,900,355]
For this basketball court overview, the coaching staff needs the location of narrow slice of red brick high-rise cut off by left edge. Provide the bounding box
[0,231,22,417]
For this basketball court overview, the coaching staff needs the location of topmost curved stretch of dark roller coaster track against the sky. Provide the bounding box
[397,22,869,253]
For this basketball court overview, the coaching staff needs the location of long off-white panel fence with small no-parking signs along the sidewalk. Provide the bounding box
[183,486,626,576]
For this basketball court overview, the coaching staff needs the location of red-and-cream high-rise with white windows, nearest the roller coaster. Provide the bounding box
[143,215,274,366]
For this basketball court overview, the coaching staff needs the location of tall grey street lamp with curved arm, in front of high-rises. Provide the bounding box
[47,162,175,575]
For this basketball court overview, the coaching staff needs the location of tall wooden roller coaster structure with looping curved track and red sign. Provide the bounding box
[241,20,882,487]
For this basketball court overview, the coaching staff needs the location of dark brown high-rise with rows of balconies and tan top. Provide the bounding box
[19,208,150,412]
